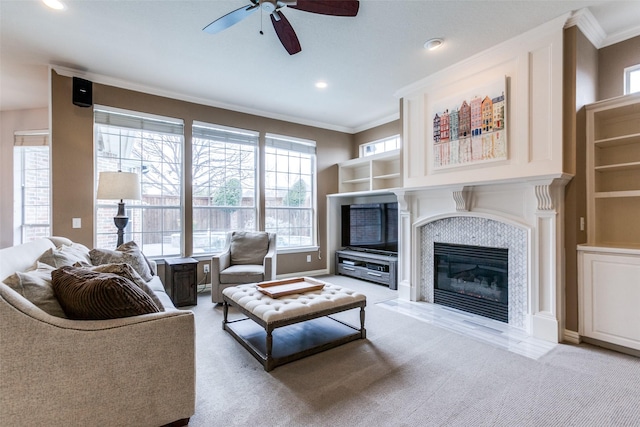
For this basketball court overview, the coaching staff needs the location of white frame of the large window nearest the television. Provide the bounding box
[262,133,319,254]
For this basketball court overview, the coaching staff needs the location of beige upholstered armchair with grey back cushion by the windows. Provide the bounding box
[211,231,276,304]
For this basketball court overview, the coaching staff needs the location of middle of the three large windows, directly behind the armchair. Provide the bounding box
[192,122,258,254]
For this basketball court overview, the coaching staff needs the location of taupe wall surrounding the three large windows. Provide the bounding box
[51,71,354,274]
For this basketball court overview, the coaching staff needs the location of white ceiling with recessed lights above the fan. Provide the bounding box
[0,0,640,132]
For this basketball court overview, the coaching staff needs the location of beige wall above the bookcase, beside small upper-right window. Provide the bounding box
[598,36,640,100]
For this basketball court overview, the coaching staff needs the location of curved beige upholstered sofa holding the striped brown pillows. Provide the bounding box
[0,238,195,427]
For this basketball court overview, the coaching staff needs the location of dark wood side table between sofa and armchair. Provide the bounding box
[164,258,198,307]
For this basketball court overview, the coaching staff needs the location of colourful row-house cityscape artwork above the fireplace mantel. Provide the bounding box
[432,77,507,169]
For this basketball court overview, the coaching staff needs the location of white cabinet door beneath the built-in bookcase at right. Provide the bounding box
[580,252,640,350]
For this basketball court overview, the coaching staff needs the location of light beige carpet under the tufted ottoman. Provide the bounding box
[189,276,640,427]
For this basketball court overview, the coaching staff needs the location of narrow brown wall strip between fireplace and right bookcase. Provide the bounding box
[563,26,598,332]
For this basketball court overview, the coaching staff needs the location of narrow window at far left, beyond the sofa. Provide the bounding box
[13,131,51,245]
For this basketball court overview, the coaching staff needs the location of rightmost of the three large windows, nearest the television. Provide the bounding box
[264,134,317,250]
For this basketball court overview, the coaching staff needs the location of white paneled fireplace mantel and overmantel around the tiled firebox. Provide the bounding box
[394,14,571,342]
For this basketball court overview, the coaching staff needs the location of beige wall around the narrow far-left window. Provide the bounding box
[0,108,49,248]
